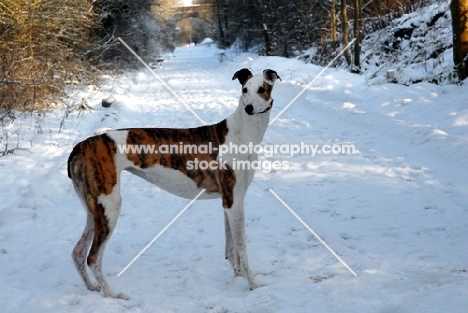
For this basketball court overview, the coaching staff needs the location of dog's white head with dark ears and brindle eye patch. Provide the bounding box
[232,68,281,115]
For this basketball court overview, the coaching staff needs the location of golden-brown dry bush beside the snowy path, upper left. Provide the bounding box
[0,0,93,113]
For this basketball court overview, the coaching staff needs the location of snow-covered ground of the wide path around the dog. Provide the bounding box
[0,39,468,313]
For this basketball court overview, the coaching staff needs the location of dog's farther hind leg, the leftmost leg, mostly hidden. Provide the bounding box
[72,211,101,291]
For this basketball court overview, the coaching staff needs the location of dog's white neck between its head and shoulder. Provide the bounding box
[227,101,270,145]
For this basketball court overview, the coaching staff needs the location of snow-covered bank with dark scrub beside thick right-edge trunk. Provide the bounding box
[362,1,458,85]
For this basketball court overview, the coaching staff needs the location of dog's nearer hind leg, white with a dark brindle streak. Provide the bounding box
[88,184,128,300]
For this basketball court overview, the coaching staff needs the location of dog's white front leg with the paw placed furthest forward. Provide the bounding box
[224,201,259,290]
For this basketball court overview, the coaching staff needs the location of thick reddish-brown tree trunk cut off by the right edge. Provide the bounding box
[450,0,468,80]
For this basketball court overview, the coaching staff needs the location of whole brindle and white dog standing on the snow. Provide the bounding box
[68,69,279,299]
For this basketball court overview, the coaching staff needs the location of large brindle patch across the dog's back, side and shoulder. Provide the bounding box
[123,120,235,207]
